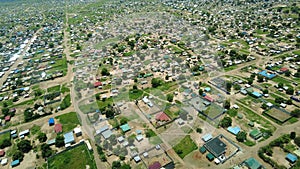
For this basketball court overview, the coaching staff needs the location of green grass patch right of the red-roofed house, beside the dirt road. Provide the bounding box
[55,112,80,132]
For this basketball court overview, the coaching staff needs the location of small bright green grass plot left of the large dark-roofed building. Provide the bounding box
[173,136,198,158]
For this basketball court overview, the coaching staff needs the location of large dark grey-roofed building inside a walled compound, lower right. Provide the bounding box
[204,137,227,158]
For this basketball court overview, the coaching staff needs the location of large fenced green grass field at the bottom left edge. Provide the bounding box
[48,144,97,169]
